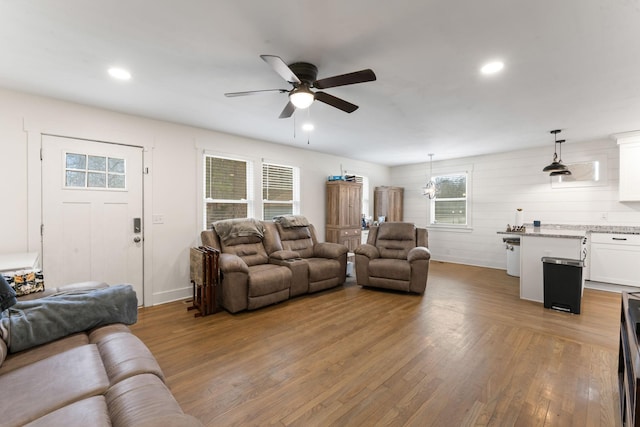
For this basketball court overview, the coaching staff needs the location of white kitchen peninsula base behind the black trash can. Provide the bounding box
[520,235,584,302]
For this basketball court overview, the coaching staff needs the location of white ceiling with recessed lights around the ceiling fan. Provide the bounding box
[0,0,640,165]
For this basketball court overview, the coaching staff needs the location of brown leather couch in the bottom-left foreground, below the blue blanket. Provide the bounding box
[0,324,202,427]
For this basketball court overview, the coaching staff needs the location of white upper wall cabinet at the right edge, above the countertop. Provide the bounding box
[617,132,640,202]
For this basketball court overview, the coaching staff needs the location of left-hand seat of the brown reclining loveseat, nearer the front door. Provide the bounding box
[200,218,292,313]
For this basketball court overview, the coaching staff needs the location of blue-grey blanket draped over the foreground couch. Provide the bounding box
[0,285,138,353]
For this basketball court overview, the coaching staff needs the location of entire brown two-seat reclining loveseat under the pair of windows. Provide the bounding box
[200,218,347,313]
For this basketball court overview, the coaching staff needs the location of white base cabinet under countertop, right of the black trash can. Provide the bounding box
[589,233,640,286]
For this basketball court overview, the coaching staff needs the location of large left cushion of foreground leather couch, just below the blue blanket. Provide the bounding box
[0,344,109,426]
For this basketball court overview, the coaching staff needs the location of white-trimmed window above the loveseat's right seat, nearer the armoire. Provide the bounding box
[262,163,300,220]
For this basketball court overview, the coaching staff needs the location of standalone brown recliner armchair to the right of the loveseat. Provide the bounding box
[354,222,431,294]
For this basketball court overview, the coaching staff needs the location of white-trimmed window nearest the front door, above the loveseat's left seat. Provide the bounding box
[204,154,253,228]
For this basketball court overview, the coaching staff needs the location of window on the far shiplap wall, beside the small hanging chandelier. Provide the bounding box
[430,172,469,226]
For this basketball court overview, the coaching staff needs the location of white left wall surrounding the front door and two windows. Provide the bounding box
[0,89,390,305]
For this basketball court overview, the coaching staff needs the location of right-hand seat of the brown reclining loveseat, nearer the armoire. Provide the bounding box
[265,215,348,297]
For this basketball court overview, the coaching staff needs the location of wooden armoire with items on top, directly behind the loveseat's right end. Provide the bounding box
[325,181,362,252]
